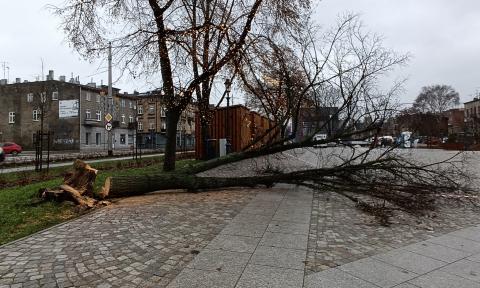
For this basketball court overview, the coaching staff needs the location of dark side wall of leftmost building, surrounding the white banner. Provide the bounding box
[0,80,80,150]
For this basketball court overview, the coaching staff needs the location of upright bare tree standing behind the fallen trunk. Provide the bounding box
[54,0,310,171]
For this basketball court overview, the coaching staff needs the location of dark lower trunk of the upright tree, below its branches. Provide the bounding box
[163,109,182,171]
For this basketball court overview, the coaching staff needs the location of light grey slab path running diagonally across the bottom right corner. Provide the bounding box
[304,226,480,288]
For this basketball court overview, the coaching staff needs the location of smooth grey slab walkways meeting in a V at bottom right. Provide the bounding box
[168,188,480,288]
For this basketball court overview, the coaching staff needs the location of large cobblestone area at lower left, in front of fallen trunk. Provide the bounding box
[0,190,254,288]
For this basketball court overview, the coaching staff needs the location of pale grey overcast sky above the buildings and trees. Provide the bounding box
[0,0,480,102]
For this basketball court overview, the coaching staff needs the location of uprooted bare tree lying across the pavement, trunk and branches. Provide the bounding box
[94,17,472,219]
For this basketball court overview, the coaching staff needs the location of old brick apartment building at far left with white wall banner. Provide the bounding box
[0,71,136,151]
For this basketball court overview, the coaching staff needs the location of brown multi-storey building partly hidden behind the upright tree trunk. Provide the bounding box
[133,90,195,149]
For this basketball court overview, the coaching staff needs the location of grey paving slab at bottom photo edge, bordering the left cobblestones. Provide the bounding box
[167,268,239,288]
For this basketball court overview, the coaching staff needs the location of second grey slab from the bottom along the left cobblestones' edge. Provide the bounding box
[187,249,251,274]
